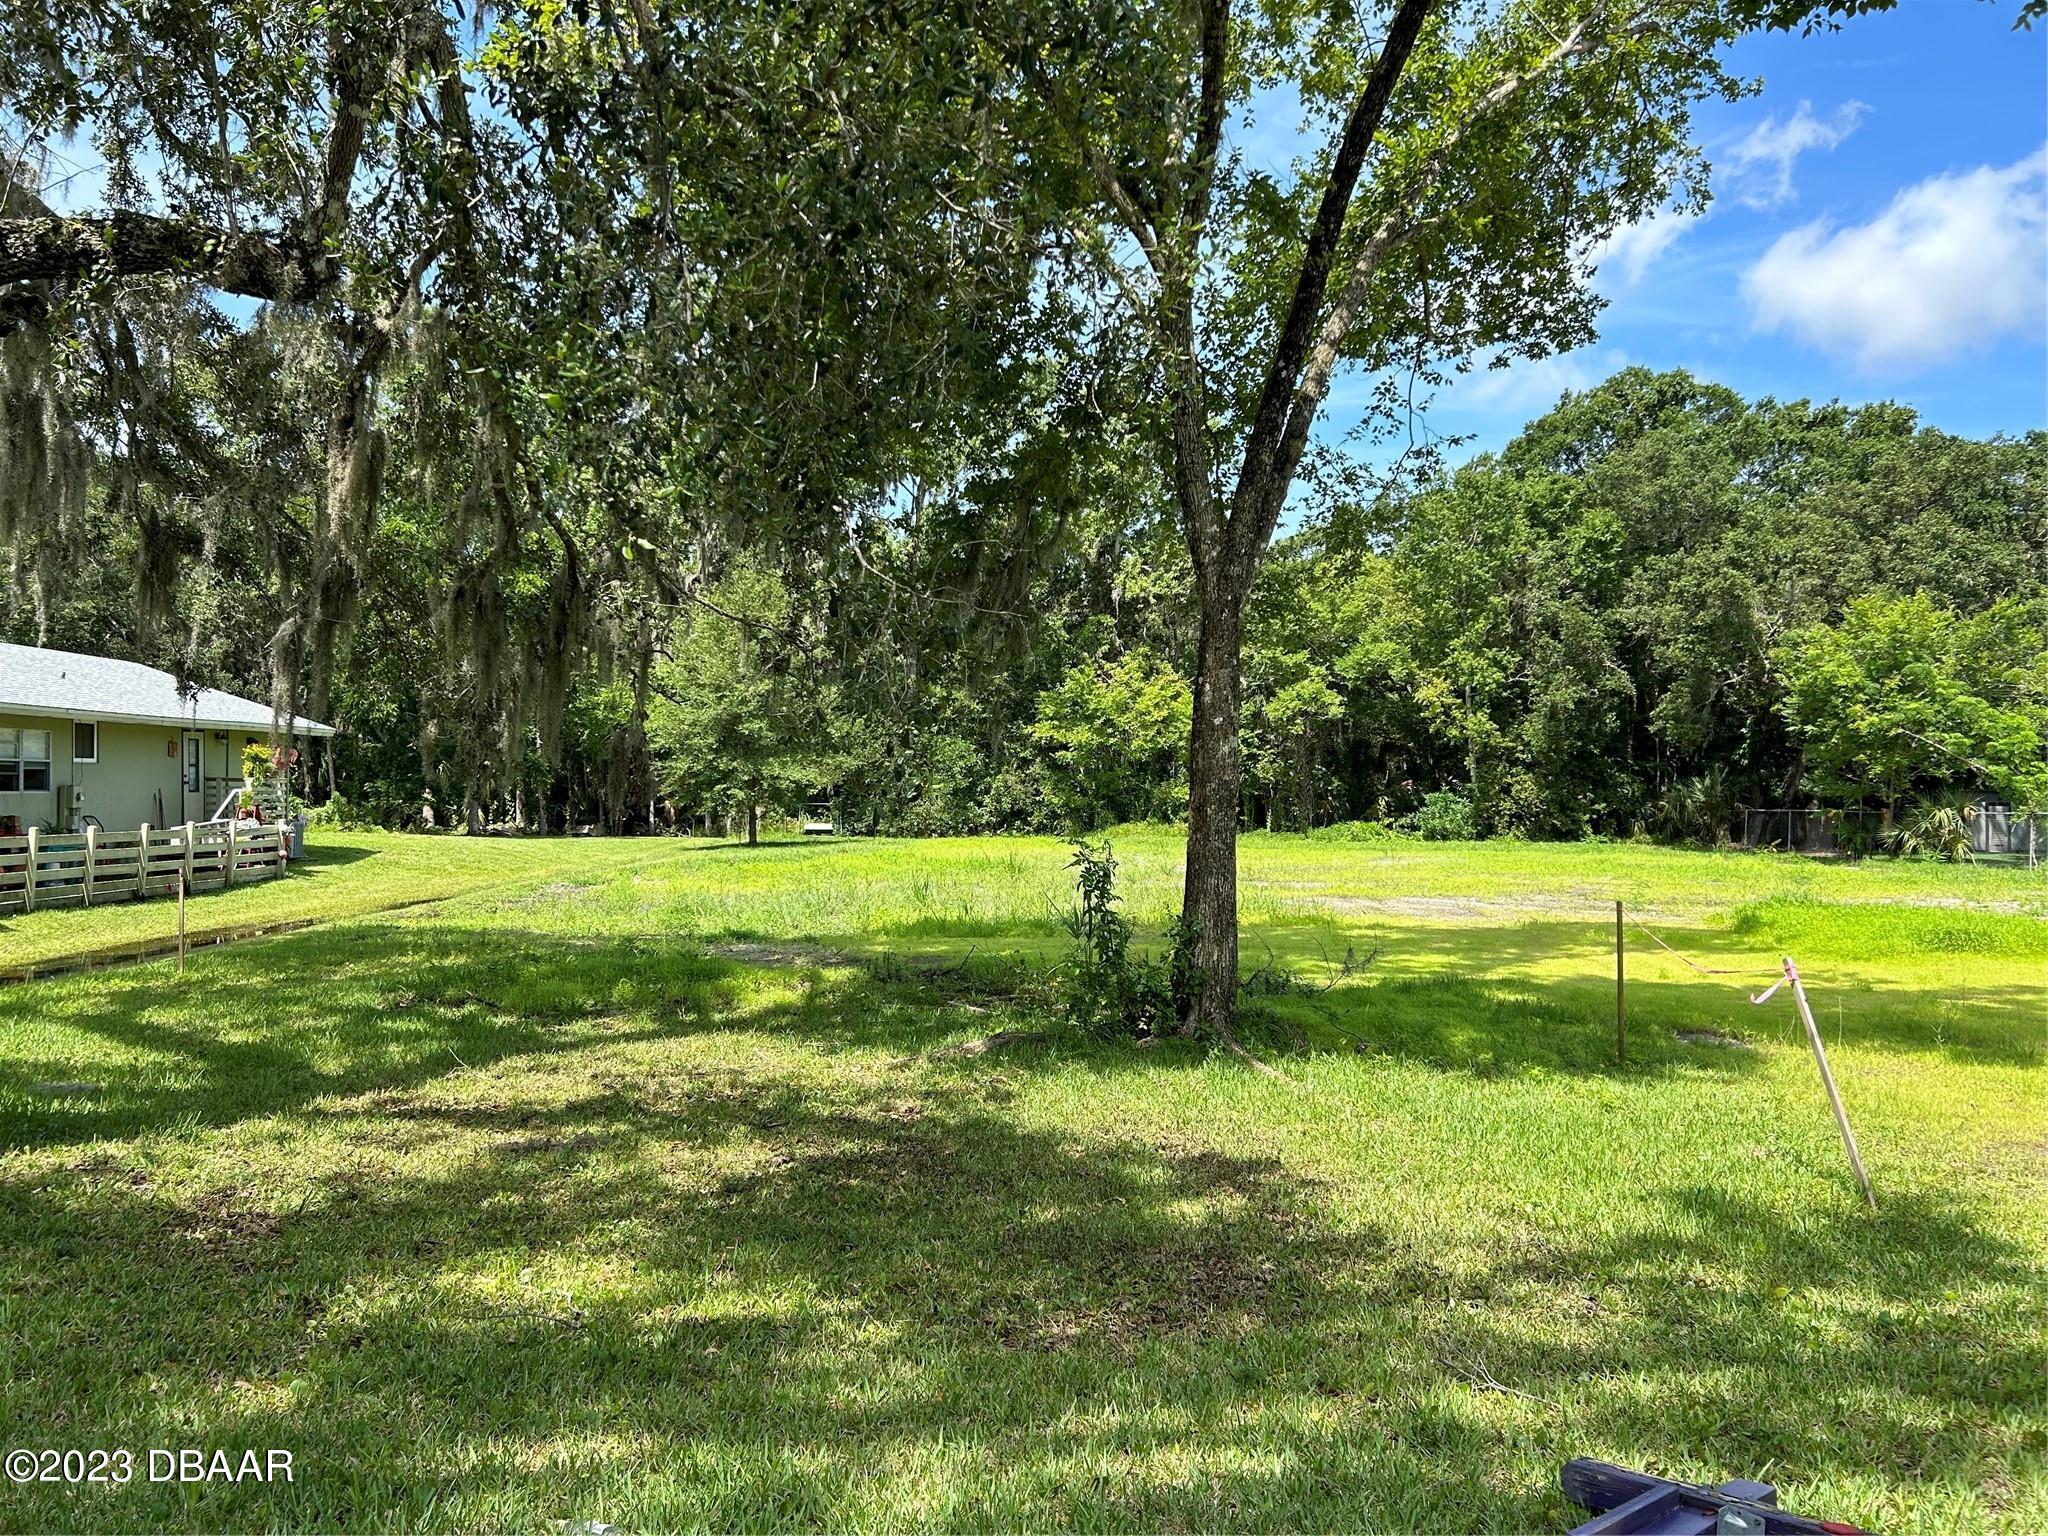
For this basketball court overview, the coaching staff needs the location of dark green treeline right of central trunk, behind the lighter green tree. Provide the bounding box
[1262,371,2048,836]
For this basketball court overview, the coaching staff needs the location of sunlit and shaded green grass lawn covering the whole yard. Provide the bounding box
[0,829,2048,1532]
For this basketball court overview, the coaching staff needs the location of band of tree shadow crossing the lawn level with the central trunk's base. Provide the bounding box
[0,901,2042,1145]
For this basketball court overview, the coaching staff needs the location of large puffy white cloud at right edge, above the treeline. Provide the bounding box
[1743,145,2048,373]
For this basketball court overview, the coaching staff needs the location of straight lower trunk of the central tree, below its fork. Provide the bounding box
[1182,584,1243,1036]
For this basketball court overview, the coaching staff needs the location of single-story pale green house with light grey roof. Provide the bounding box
[0,645,334,831]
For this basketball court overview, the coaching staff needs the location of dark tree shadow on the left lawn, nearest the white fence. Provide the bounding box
[0,922,739,1147]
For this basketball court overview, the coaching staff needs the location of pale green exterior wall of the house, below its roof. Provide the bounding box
[0,711,268,831]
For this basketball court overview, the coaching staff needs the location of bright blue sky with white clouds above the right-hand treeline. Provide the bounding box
[1321,0,2048,459]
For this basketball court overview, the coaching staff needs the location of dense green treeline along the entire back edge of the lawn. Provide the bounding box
[4,369,2048,840]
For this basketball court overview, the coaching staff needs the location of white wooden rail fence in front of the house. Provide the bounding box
[0,821,291,911]
